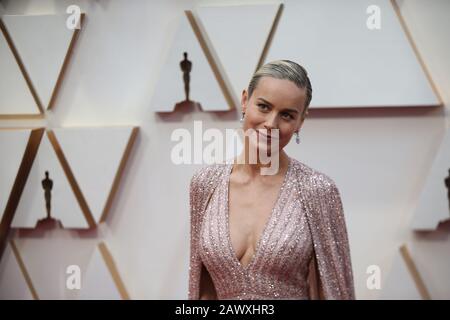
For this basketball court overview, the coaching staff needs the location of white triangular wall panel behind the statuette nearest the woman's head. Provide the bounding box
[151,11,237,112]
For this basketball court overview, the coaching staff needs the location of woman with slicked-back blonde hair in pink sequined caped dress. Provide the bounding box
[189,60,354,299]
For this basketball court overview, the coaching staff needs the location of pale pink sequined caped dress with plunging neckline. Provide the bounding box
[188,158,354,300]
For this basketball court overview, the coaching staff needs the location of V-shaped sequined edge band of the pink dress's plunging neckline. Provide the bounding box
[225,158,292,271]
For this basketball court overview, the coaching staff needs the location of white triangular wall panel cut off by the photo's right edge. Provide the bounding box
[411,130,450,231]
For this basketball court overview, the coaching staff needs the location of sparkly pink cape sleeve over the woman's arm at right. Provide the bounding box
[309,175,355,299]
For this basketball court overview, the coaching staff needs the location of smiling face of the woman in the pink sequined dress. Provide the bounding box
[241,77,306,158]
